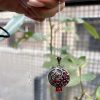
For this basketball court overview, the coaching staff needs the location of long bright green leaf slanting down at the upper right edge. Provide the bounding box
[83,21,100,39]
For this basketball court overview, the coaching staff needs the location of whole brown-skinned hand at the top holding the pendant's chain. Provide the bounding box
[0,0,64,21]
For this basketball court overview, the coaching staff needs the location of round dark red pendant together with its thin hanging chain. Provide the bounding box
[48,1,70,92]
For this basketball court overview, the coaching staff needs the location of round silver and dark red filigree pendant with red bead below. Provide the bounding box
[48,57,70,92]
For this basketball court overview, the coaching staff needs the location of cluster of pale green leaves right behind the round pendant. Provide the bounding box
[43,49,96,86]
